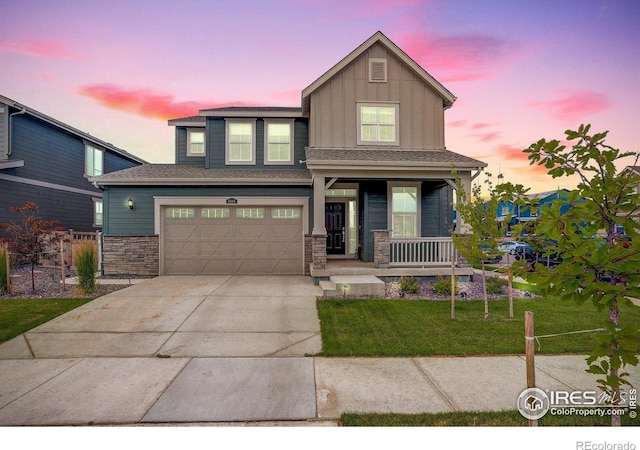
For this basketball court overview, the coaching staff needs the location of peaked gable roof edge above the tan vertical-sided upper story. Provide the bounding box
[302,31,456,111]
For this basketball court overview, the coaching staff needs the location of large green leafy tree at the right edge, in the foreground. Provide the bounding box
[522,125,640,425]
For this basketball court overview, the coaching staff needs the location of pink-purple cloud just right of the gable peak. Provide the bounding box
[396,31,523,82]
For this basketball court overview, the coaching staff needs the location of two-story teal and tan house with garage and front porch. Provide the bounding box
[92,32,486,276]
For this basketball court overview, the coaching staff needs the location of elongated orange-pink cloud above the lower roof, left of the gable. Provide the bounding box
[78,84,250,120]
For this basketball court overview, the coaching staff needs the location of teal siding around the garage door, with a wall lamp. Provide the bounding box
[103,186,313,235]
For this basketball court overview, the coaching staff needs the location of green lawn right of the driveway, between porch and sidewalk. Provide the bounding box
[317,298,640,356]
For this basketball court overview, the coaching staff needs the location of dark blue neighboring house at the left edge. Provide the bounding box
[0,95,145,231]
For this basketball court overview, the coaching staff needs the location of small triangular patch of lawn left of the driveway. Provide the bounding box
[0,298,93,342]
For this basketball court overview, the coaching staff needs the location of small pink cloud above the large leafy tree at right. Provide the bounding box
[526,90,613,124]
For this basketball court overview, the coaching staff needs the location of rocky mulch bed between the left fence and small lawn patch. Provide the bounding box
[0,265,129,300]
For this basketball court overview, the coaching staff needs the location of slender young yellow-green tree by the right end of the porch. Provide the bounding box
[451,173,500,319]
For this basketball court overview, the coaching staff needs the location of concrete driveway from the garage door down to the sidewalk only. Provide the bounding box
[0,276,322,358]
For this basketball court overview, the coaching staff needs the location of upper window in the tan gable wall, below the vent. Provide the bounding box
[358,103,400,145]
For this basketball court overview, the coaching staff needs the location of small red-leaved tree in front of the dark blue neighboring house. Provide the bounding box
[0,201,57,292]
